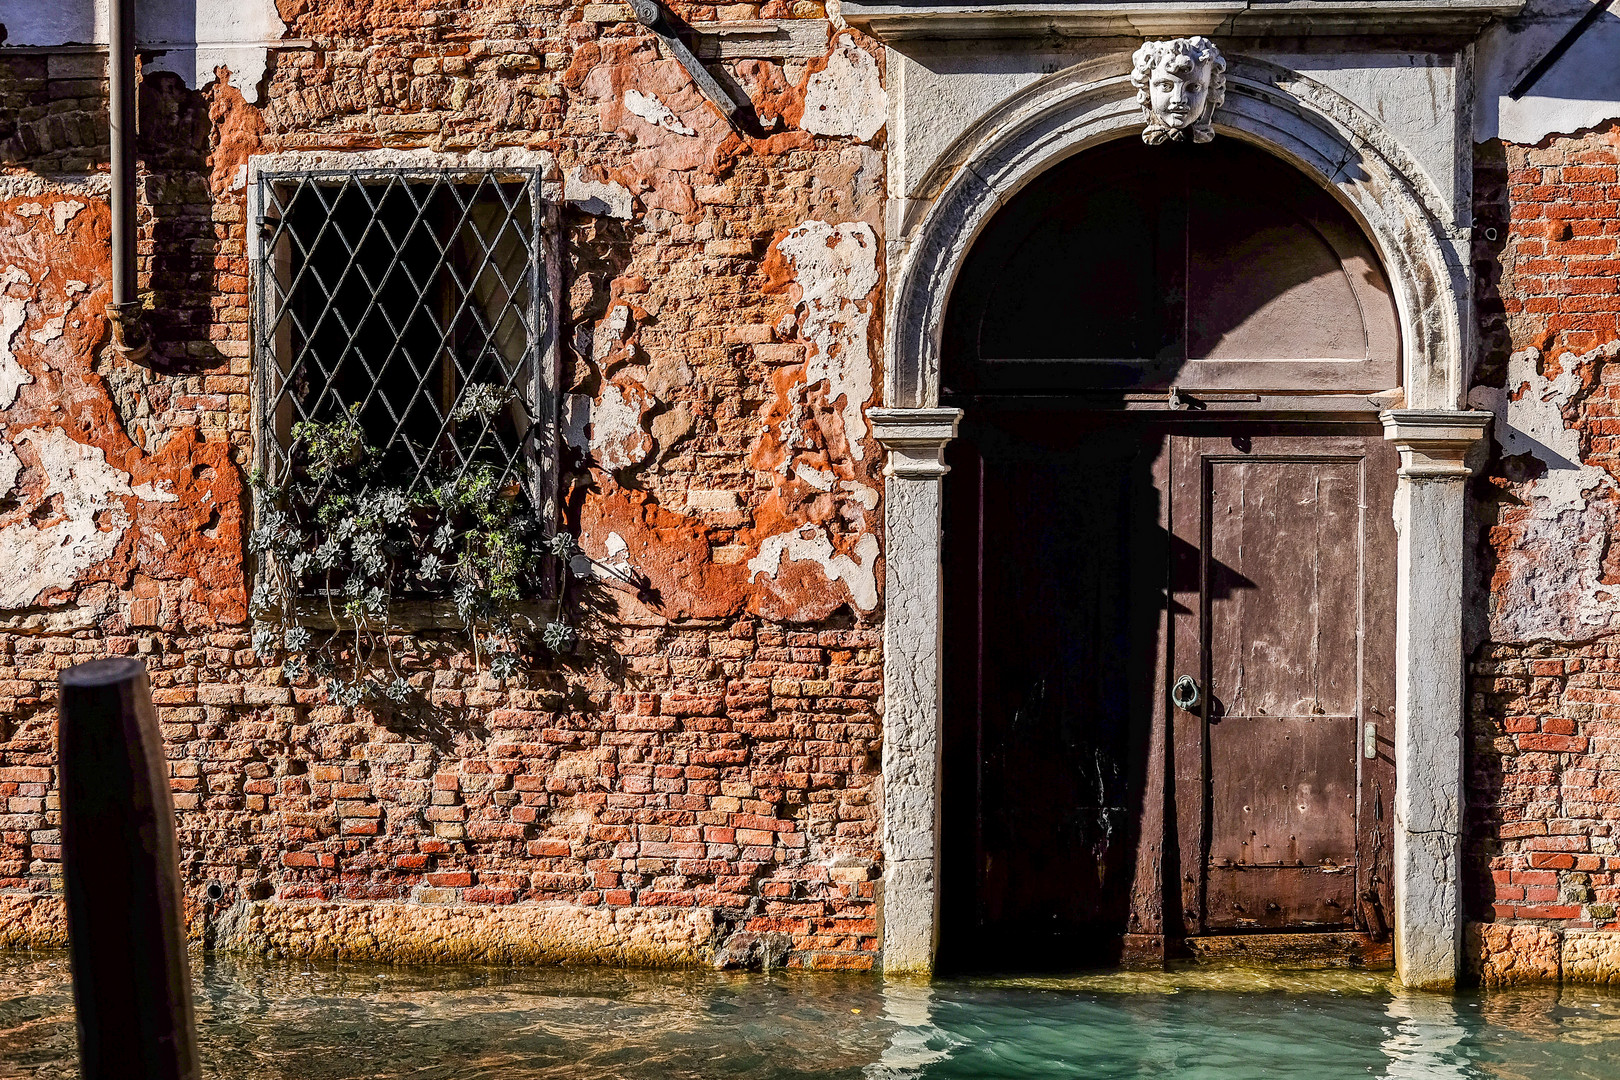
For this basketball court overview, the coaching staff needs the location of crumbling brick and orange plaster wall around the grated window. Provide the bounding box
[0,0,885,968]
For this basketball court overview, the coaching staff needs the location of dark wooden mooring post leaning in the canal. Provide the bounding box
[57,659,201,1080]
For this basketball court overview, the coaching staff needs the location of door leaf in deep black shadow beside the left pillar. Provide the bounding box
[941,410,1168,967]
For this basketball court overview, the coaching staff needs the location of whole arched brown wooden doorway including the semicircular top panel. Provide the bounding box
[940,139,1401,968]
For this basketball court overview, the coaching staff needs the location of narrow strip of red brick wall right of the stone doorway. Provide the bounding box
[1464,125,1620,983]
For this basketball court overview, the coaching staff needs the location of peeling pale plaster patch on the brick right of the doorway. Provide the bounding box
[1468,342,1620,643]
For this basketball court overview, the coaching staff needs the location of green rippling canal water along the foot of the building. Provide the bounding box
[0,952,1620,1080]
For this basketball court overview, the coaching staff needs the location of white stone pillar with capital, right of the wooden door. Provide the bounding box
[1380,410,1490,989]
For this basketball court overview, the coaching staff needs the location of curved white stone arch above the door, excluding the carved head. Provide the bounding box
[886,53,1473,408]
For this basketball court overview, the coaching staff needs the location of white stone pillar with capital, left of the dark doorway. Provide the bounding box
[867,408,962,973]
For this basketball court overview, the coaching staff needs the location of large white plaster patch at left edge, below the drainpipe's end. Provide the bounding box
[0,427,134,609]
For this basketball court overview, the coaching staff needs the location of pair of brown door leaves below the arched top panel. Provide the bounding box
[941,417,1395,967]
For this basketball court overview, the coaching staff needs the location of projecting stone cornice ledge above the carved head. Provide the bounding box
[842,0,1526,40]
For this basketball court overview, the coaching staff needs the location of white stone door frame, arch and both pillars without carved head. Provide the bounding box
[868,50,1489,988]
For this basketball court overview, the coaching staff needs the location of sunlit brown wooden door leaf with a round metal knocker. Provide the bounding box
[1168,429,1395,934]
